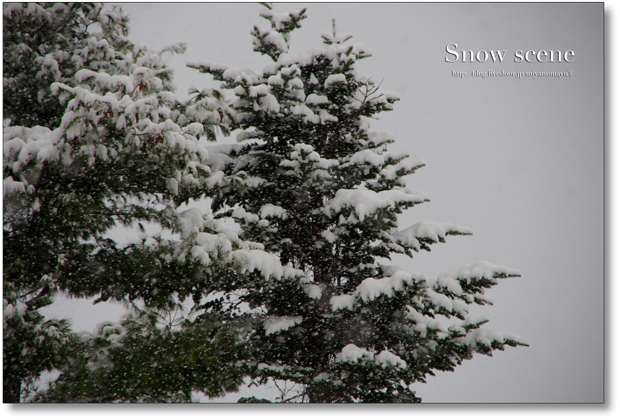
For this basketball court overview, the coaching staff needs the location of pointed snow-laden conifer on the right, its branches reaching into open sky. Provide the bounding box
[188,4,527,402]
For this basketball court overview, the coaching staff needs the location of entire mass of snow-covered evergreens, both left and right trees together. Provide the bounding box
[2,3,527,402]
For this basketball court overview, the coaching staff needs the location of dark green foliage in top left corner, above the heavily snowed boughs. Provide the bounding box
[2,3,127,127]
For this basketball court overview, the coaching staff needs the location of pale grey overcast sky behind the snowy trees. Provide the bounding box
[41,3,603,402]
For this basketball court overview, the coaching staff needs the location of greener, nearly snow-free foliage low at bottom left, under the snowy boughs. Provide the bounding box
[35,310,242,403]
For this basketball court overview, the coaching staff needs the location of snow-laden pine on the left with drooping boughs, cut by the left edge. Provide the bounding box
[2,3,299,402]
